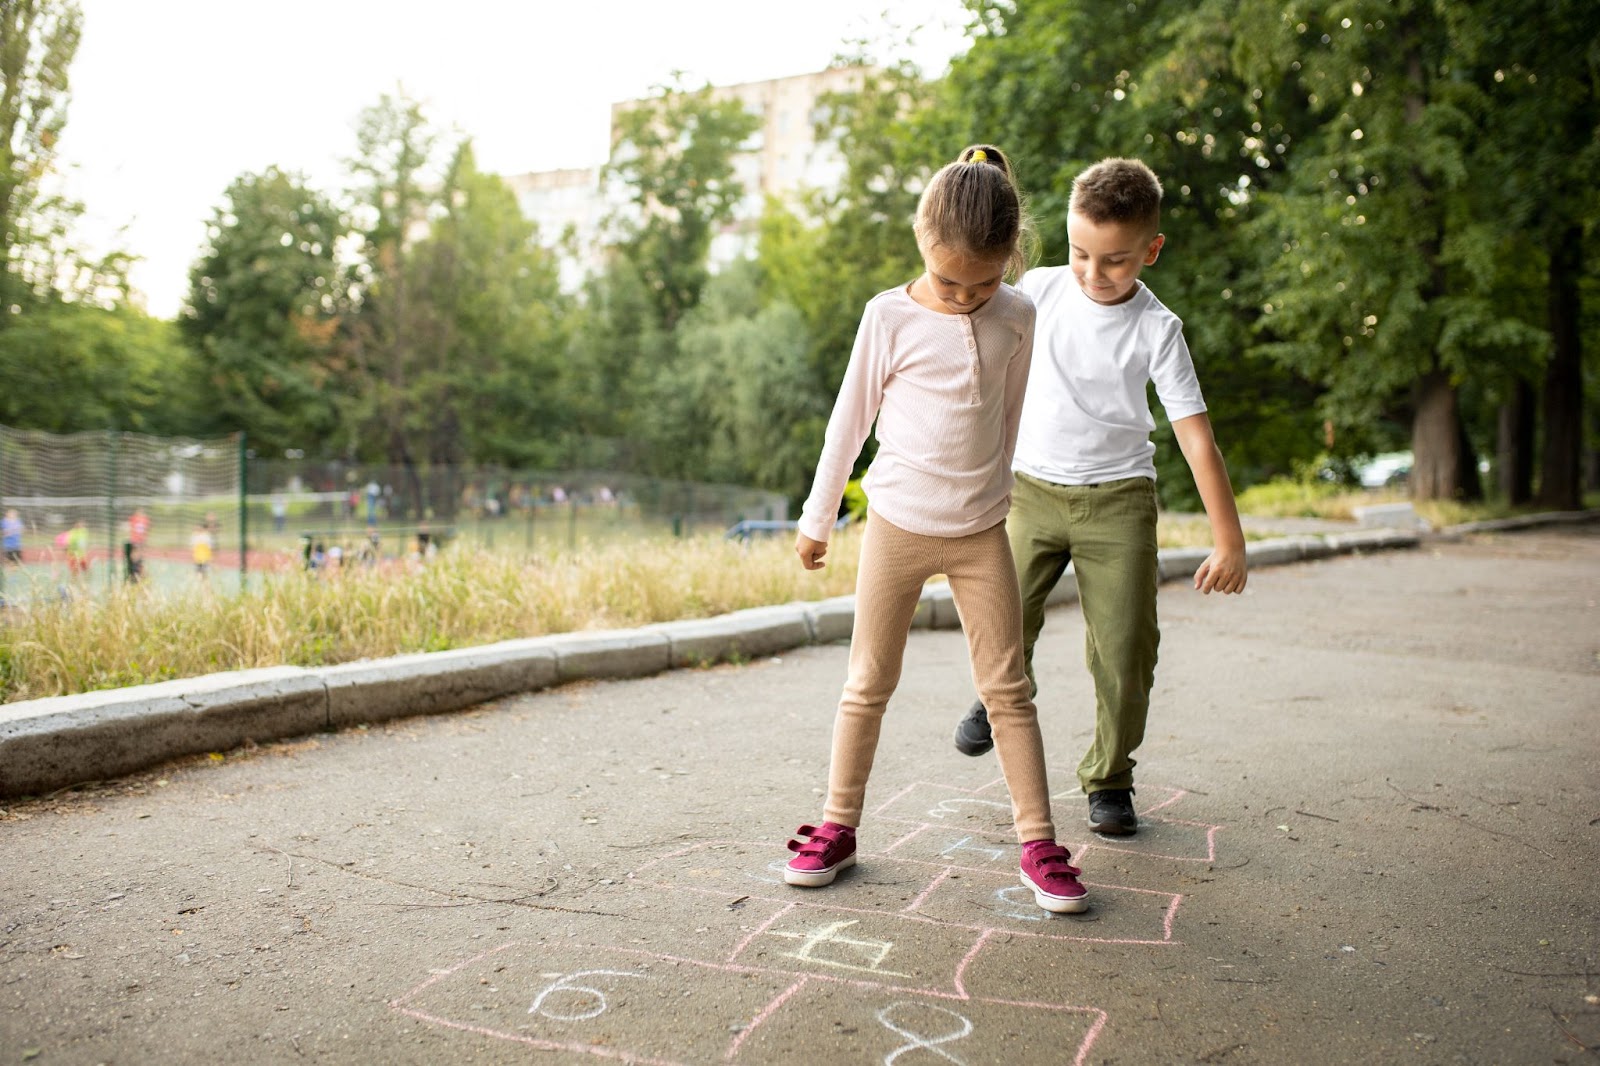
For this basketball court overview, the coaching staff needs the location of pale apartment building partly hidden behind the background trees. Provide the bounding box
[506,67,862,288]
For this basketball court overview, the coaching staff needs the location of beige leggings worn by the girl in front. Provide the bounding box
[822,512,1056,844]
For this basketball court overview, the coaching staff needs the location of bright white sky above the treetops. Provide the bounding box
[59,0,966,319]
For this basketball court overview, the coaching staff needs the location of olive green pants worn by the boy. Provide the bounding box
[1006,474,1162,794]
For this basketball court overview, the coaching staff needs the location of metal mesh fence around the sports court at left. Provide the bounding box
[0,426,789,591]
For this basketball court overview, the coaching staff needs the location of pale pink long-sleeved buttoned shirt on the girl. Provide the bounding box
[800,285,1034,541]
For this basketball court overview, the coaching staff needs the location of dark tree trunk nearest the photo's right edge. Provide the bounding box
[1536,226,1584,511]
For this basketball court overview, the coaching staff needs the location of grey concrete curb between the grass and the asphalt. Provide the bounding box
[0,511,1600,799]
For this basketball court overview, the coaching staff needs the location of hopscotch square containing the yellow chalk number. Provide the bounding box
[728,904,984,994]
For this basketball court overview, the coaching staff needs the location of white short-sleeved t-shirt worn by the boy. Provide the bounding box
[1013,267,1205,485]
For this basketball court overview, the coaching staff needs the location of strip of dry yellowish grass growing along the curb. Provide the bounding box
[0,519,1273,703]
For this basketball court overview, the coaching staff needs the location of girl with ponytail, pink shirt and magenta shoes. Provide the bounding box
[784,144,1088,912]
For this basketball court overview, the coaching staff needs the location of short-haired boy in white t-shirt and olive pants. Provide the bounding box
[955,158,1245,836]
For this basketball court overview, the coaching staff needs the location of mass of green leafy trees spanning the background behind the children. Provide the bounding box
[0,0,1600,507]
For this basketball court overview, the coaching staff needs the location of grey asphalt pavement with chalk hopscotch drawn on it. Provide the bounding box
[0,522,1600,1066]
